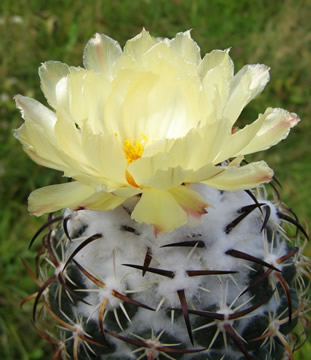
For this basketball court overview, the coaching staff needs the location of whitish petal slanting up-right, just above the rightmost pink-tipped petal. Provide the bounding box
[223,64,270,125]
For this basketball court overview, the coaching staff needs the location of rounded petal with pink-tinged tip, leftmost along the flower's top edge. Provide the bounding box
[83,34,122,76]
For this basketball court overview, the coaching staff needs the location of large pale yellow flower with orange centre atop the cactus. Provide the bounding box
[15,30,299,231]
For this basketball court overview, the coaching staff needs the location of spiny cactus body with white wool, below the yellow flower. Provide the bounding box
[25,184,310,360]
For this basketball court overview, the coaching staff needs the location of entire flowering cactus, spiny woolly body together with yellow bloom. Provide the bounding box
[15,30,310,360]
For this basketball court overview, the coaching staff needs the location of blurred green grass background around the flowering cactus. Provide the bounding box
[0,0,311,360]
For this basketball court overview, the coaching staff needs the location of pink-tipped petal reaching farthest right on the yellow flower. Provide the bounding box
[237,108,300,155]
